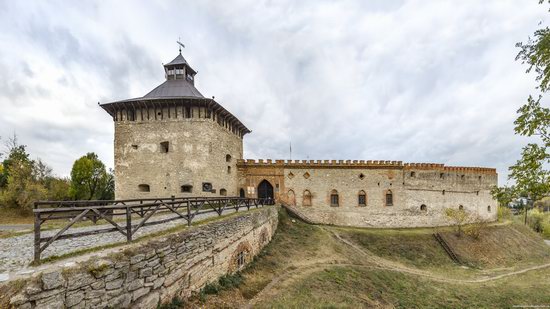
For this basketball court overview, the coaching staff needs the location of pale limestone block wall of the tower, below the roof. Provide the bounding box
[114,112,243,199]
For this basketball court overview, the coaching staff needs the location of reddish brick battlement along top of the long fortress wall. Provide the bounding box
[237,159,496,174]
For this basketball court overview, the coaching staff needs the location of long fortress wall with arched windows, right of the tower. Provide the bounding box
[238,160,497,228]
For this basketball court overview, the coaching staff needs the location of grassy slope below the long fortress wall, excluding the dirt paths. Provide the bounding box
[180,211,550,308]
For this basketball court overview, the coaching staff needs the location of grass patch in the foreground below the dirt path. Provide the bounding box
[257,267,550,308]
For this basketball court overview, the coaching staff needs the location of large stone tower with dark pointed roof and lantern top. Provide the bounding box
[100,50,250,199]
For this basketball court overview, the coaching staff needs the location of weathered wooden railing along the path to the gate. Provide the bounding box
[33,197,274,262]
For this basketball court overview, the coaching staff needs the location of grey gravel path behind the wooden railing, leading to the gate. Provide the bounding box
[0,209,235,274]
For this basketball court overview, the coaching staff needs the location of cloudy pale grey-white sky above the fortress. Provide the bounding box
[0,0,550,184]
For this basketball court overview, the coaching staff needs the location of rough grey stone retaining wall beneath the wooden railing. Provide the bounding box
[0,206,278,308]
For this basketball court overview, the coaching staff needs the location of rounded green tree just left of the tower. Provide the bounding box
[70,152,114,200]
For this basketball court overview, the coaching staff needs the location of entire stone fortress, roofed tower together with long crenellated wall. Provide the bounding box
[100,50,497,227]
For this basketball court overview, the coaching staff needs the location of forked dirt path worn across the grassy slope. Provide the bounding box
[243,228,550,309]
